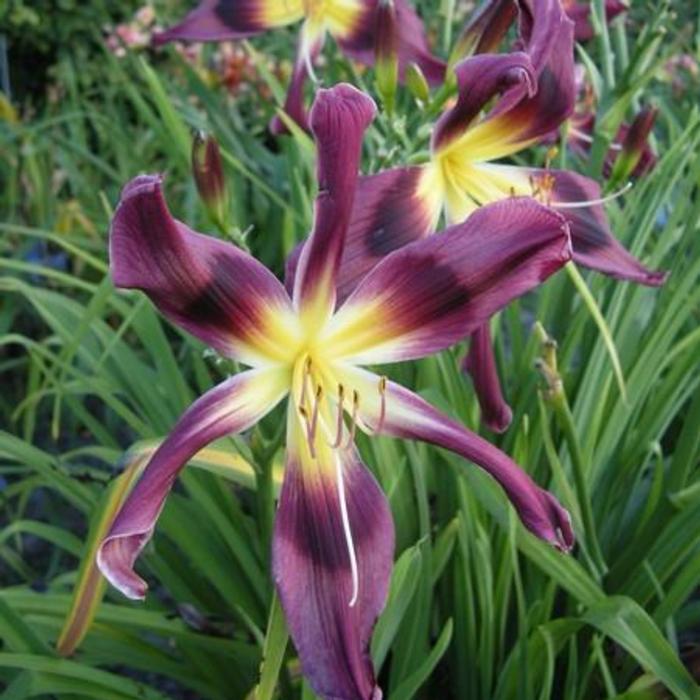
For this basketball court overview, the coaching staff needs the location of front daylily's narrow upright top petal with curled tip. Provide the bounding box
[294,83,376,314]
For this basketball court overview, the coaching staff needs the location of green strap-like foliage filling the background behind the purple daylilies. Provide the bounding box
[0,0,700,700]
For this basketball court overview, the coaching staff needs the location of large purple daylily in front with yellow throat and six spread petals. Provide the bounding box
[97,85,573,700]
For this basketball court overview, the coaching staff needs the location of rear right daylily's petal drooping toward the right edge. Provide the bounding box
[540,168,667,287]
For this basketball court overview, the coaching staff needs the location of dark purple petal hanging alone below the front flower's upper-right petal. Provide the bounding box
[464,323,513,433]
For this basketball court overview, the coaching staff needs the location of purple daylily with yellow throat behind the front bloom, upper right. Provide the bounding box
[288,0,665,432]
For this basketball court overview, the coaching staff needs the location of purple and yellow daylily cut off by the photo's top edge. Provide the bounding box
[154,0,445,133]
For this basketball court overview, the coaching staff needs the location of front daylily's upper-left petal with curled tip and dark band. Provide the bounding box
[109,175,293,364]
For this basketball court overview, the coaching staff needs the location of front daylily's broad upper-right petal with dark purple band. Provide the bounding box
[327,198,571,364]
